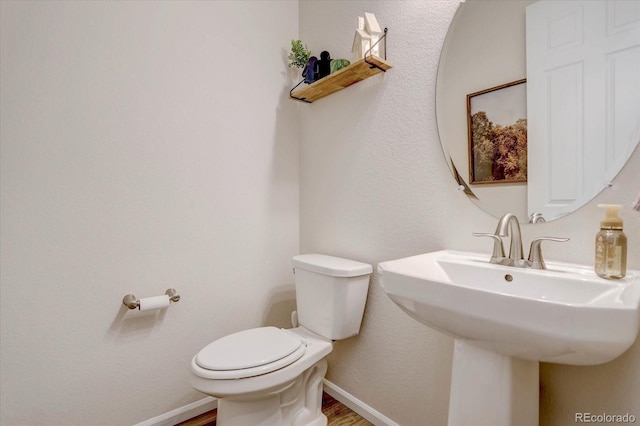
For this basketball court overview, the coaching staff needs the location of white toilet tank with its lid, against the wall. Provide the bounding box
[293,254,373,340]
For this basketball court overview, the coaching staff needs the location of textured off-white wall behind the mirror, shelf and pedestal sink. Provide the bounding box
[300,0,640,426]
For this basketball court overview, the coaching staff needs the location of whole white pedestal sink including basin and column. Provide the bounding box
[378,250,640,426]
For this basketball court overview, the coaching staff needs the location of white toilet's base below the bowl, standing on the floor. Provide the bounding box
[216,358,327,426]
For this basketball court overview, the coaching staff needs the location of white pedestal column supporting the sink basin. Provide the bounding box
[449,339,539,426]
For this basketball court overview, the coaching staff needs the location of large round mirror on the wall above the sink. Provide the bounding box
[436,0,640,222]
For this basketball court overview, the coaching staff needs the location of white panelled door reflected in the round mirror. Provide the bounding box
[526,0,640,218]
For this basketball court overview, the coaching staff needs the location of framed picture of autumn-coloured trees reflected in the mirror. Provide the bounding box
[467,78,527,184]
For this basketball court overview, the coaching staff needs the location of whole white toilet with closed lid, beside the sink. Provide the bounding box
[191,254,373,426]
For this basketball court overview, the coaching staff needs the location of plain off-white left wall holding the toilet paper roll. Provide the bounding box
[0,1,298,426]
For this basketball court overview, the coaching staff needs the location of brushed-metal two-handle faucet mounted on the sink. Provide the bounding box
[473,213,569,269]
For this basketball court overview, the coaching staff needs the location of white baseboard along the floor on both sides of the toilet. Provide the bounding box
[134,379,399,426]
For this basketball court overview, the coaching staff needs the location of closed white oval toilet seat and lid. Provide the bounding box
[195,327,306,379]
